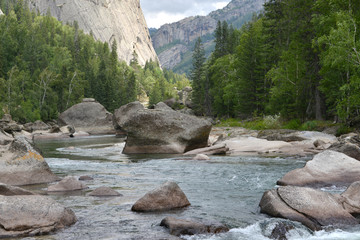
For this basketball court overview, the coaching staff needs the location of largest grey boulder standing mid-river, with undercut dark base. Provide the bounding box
[114,102,211,153]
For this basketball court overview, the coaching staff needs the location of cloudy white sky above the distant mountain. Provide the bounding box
[140,0,230,28]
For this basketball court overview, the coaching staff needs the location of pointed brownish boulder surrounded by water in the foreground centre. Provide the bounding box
[131,182,190,212]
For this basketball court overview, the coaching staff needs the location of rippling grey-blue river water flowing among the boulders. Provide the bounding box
[18,136,360,240]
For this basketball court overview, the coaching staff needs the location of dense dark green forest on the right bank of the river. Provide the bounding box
[192,0,360,125]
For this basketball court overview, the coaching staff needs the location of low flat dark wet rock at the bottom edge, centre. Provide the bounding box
[160,217,229,236]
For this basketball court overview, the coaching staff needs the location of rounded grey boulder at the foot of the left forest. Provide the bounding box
[58,98,115,134]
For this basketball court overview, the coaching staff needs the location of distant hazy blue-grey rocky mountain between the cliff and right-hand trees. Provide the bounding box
[151,0,265,73]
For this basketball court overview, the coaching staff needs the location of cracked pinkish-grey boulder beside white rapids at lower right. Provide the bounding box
[260,186,358,230]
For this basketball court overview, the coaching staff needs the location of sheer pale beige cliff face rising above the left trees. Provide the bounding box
[29,0,157,65]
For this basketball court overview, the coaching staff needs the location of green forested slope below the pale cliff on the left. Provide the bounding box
[0,0,189,122]
